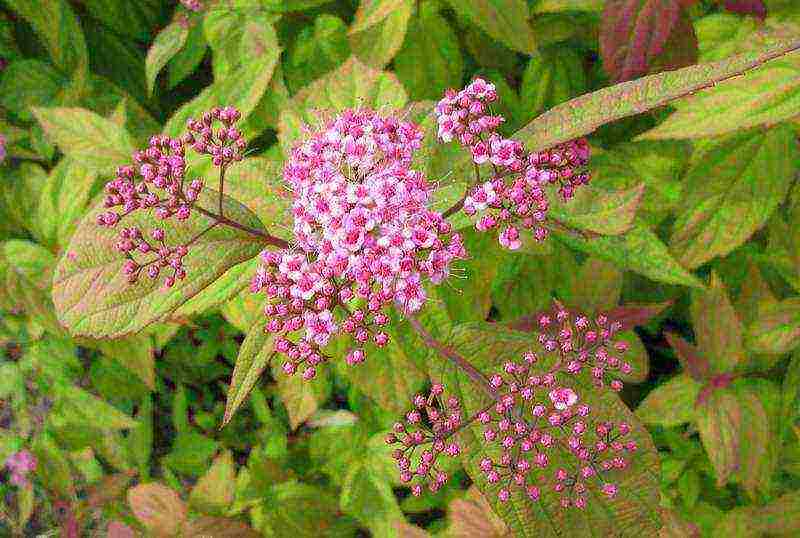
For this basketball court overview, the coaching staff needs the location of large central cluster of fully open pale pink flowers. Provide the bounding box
[251,109,466,379]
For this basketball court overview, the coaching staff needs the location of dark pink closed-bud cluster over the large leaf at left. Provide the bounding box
[97,107,246,288]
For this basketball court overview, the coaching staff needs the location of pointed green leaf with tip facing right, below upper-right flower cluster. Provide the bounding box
[555,220,703,288]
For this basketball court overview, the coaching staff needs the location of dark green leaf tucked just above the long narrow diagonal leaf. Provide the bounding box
[520,46,586,121]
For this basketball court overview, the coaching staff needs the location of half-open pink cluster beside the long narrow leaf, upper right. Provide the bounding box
[436,78,589,250]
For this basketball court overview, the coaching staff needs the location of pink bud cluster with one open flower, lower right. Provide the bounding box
[477,353,637,509]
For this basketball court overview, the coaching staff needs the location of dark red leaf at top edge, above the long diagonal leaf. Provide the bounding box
[600,0,697,81]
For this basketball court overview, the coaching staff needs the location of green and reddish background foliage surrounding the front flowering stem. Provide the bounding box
[0,0,800,536]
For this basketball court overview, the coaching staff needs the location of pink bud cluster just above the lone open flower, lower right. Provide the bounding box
[538,303,633,392]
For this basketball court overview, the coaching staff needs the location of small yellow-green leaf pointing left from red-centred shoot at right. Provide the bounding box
[636,374,701,428]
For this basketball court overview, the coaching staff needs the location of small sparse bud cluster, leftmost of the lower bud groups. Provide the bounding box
[386,383,462,496]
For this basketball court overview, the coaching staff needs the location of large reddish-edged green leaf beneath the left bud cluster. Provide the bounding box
[53,188,263,337]
